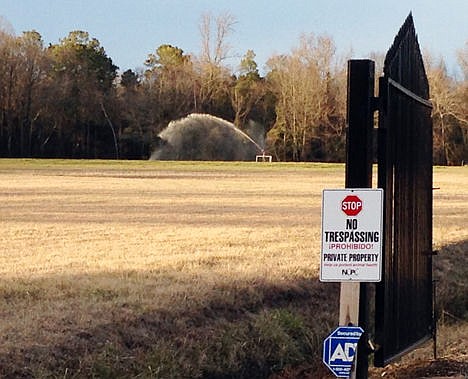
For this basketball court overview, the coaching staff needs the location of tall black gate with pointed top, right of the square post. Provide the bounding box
[374,14,433,366]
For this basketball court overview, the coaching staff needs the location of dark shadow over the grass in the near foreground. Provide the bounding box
[0,241,468,379]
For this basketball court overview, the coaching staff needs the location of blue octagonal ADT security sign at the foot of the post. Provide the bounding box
[323,326,364,378]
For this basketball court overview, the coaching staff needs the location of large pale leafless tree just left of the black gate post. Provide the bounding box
[268,35,344,161]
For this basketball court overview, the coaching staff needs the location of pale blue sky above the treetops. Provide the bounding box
[0,0,468,73]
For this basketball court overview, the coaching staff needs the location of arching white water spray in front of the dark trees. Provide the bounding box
[150,113,265,161]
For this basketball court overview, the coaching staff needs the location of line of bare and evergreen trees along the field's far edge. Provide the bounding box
[0,14,468,164]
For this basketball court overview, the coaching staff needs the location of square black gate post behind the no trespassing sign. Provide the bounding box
[339,59,375,379]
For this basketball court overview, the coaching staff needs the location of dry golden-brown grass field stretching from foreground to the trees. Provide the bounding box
[0,160,468,378]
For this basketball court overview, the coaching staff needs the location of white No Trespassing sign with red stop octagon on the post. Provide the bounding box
[320,188,383,282]
